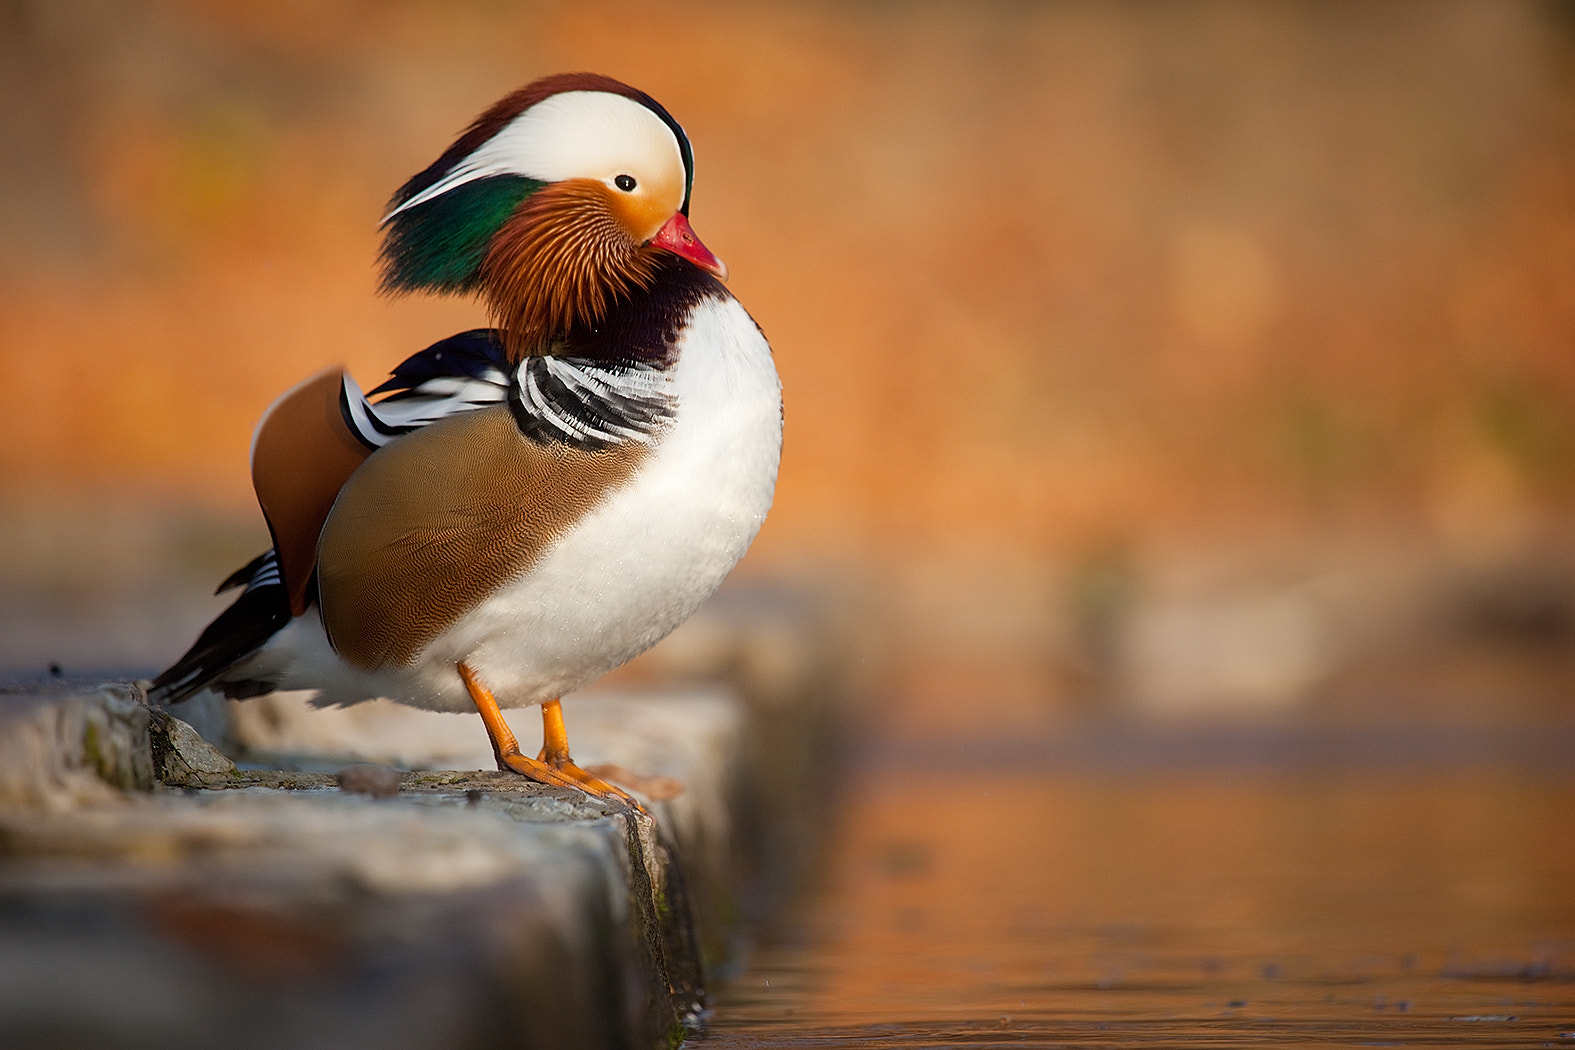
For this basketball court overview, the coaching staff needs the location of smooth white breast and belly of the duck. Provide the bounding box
[417,298,781,710]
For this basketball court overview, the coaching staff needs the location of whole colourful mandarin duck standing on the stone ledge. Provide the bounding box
[150,74,783,806]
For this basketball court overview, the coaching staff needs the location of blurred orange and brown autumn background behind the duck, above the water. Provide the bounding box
[0,0,1575,734]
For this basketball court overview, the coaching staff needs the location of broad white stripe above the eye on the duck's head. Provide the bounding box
[383,91,685,222]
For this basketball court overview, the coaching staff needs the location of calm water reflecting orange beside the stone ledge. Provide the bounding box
[696,730,1575,1050]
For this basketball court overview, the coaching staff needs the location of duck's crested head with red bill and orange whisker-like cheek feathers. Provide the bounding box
[383,72,726,357]
